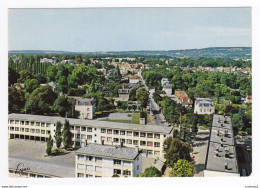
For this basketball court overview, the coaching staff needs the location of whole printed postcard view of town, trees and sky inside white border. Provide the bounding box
[6,8,252,178]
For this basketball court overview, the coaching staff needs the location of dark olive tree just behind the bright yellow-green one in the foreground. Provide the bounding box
[164,138,192,167]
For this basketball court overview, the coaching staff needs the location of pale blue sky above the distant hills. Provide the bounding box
[8,8,252,52]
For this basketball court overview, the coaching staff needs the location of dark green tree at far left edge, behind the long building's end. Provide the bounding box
[8,86,25,113]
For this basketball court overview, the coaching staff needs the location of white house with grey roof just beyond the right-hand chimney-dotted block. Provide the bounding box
[194,98,215,114]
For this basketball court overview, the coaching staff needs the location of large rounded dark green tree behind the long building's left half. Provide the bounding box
[25,85,57,115]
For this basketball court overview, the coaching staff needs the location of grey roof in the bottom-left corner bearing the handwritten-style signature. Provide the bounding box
[8,156,75,178]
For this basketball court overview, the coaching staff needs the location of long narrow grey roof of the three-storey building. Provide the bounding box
[8,113,173,134]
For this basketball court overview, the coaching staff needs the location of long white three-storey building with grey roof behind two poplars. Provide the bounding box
[8,113,173,157]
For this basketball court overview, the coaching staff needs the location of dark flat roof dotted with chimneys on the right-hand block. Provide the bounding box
[205,114,238,173]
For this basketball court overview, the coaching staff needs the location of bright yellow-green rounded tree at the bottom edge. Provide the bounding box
[170,159,196,177]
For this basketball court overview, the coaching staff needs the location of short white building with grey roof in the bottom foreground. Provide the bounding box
[75,144,142,178]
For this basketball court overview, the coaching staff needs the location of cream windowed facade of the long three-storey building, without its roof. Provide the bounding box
[8,120,172,157]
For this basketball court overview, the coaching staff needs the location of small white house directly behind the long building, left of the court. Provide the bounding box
[75,98,96,119]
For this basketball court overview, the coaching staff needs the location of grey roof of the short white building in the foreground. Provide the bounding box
[76,144,140,160]
